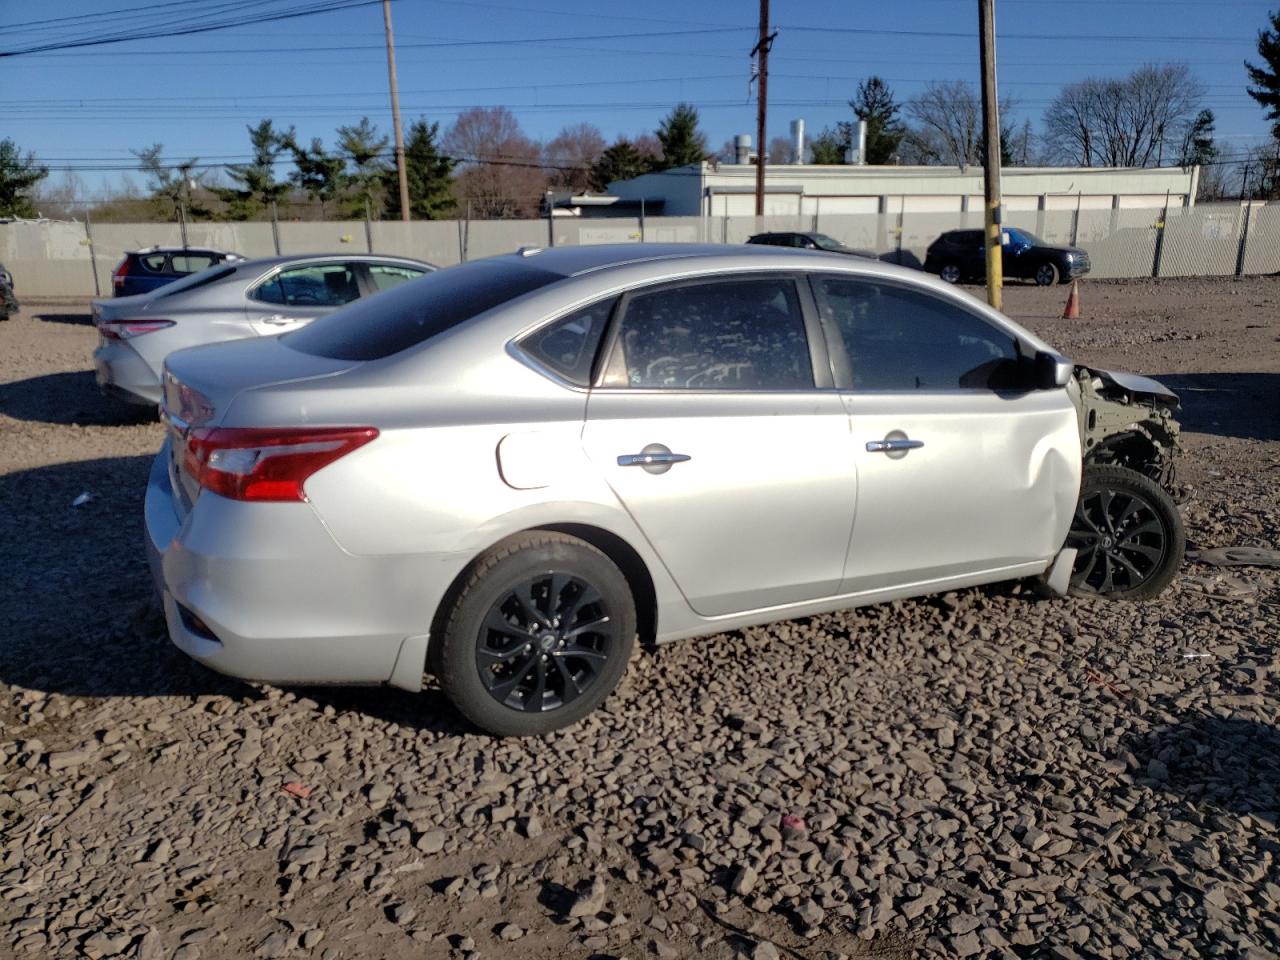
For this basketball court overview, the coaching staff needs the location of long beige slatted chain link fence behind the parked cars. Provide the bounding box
[0,202,1280,298]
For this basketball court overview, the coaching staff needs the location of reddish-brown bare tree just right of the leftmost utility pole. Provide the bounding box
[442,106,547,219]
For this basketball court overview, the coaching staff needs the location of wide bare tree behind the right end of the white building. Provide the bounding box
[1044,64,1204,166]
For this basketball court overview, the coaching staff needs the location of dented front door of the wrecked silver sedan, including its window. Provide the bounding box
[813,274,1080,593]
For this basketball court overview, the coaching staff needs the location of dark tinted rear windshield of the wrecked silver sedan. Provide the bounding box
[280,260,564,360]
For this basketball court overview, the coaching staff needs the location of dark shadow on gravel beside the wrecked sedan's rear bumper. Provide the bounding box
[0,456,259,699]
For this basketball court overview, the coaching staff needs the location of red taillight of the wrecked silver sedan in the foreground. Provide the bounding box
[183,426,378,502]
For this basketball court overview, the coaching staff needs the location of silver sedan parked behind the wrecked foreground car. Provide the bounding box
[92,253,435,406]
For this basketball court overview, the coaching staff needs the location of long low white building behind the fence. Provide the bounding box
[608,161,1199,216]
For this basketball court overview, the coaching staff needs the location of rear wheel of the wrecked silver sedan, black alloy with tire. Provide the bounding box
[438,531,636,736]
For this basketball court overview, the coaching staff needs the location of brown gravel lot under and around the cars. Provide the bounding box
[0,278,1280,960]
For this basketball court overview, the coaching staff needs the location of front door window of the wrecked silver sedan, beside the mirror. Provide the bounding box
[814,276,1024,392]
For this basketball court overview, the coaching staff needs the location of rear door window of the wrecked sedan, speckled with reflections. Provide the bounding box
[604,278,814,390]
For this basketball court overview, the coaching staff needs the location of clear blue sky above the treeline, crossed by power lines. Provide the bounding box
[0,0,1280,192]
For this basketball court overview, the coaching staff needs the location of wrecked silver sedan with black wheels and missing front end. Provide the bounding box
[146,244,1183,735]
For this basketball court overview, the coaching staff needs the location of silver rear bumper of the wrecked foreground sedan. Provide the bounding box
[145,443,465,690]
